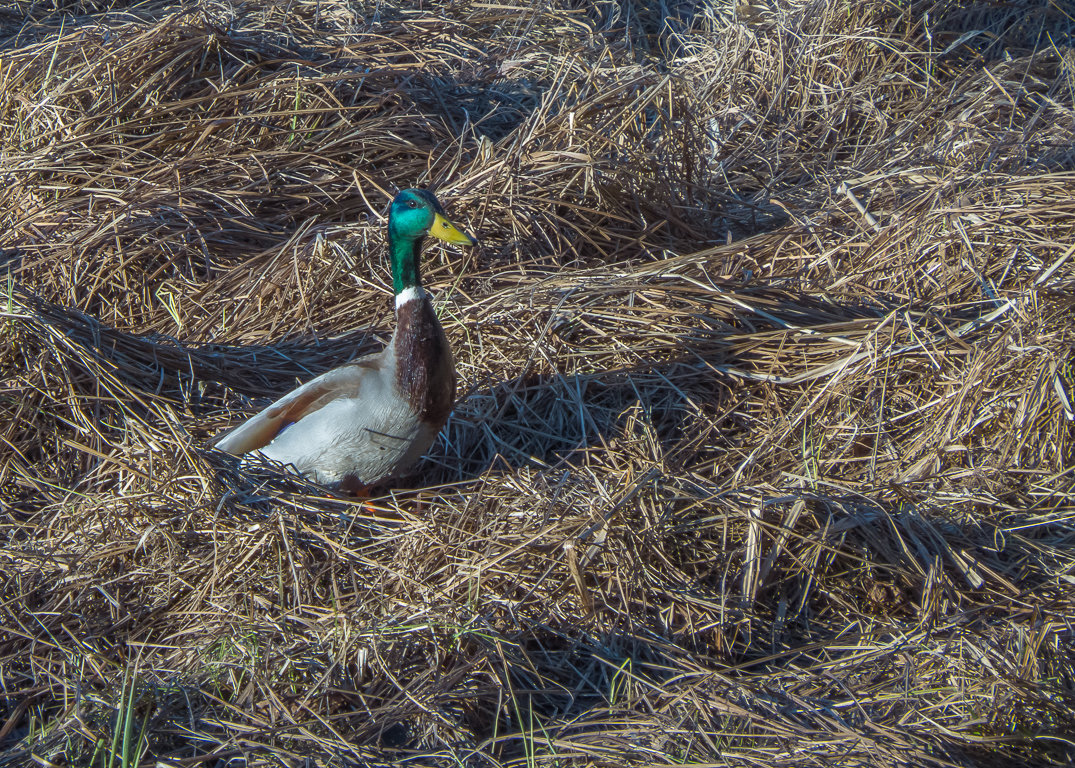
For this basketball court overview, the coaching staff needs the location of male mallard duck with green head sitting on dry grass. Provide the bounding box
[216,189,477,494]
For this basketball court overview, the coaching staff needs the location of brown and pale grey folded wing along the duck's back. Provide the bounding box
[214,353,382,456]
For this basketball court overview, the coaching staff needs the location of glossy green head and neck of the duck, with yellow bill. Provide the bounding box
[388,189,477,295]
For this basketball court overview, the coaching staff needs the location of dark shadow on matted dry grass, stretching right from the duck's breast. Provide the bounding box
[414,356,736,485]
